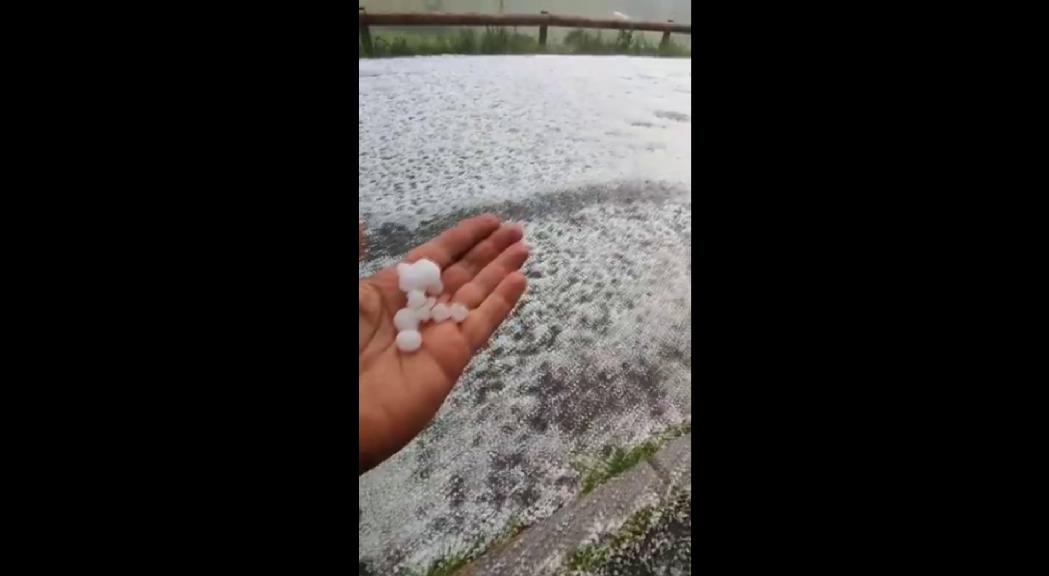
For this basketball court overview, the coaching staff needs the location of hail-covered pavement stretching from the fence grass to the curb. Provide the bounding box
[358,57,692,574]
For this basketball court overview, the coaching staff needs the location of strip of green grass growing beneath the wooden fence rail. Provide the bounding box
[358,27,692,58]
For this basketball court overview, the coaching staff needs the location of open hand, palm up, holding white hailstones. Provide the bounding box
[358,215,529,472]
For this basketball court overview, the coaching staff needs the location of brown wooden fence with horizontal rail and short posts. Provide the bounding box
[357,8,692,56]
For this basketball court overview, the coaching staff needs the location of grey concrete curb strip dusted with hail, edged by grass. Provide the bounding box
[458,433,692,576]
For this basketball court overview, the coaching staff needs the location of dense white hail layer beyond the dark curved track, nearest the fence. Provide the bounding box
[358,56,692,233]
